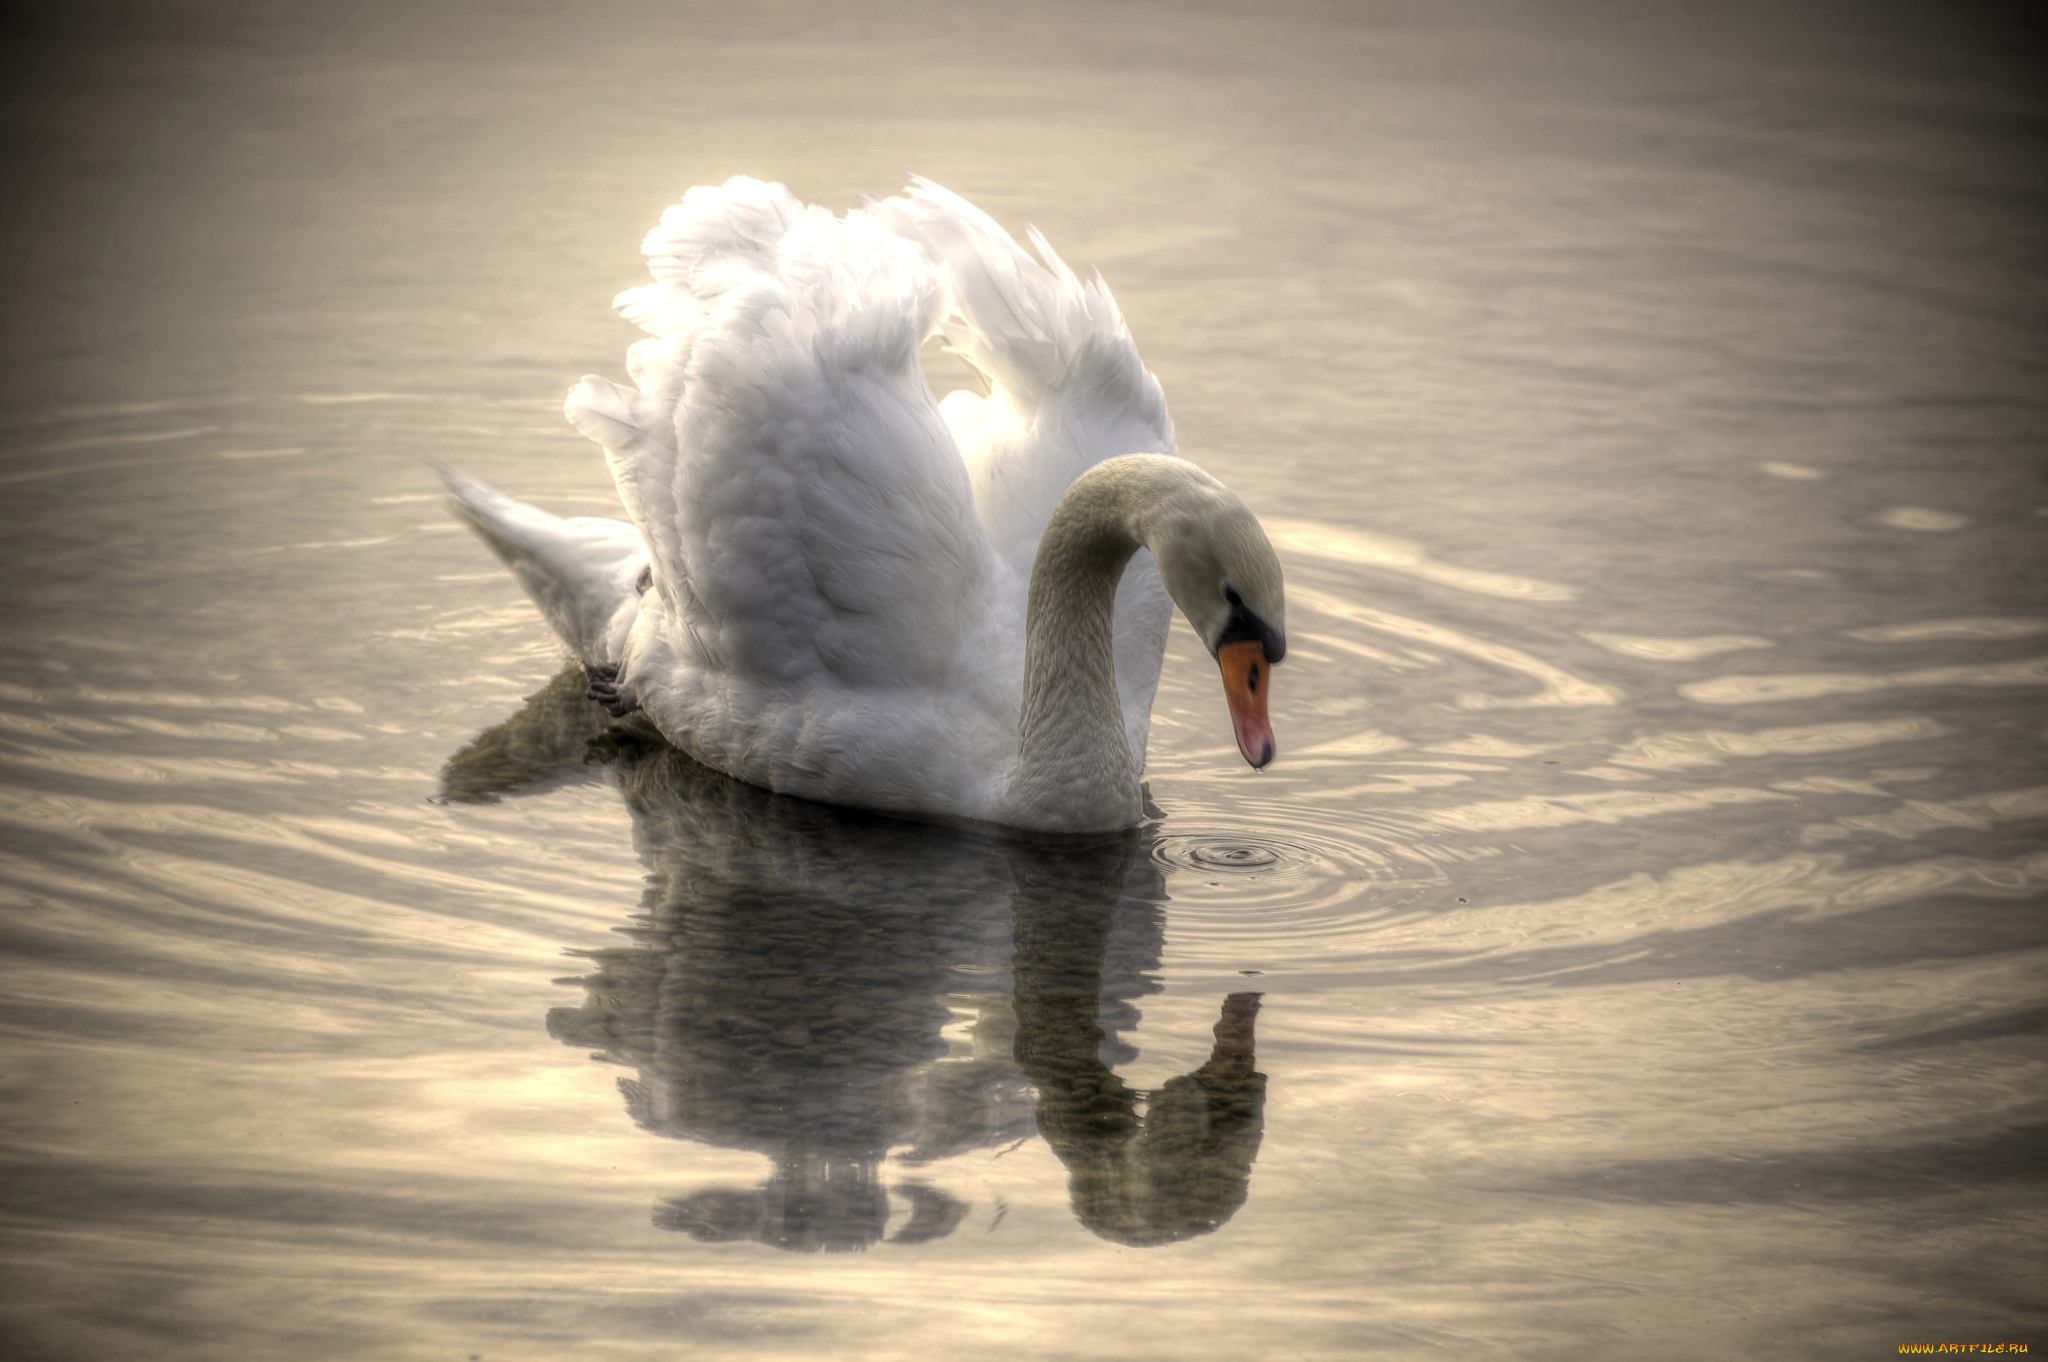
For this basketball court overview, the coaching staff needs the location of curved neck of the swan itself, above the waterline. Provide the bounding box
[1004,459,1178,832]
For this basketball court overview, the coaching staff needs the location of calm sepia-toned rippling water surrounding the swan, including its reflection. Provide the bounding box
[0,0,2048,1362]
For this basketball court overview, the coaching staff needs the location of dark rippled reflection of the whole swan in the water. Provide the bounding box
[444,672,1266,1249]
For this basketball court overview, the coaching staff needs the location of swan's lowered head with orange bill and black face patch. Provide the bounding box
[1145,459,1286,768]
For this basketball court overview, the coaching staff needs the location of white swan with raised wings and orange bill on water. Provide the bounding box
[442,178,1286,832]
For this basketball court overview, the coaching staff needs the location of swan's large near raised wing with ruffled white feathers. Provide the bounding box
[569,180,991,688]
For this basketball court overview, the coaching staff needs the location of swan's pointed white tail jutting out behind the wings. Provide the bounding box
[434,465,649,668]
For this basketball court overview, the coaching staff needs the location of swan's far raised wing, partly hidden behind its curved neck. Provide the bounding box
[874,178,1176,576]
